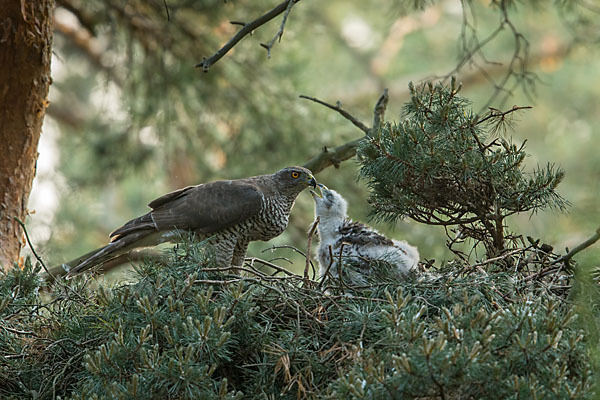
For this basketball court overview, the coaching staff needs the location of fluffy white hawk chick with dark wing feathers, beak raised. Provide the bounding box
[311,185,419,285]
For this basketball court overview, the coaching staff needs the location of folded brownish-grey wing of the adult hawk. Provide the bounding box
[110,181,263,241]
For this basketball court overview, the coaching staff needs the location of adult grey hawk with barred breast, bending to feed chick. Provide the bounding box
[63,167,317,275]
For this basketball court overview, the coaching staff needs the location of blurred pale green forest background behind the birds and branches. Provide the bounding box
[28,0,600,276]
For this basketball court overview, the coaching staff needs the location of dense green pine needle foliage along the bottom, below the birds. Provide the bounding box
[0,244,599,399]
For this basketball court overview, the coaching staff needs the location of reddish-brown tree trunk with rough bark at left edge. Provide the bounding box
[0,0,54,269]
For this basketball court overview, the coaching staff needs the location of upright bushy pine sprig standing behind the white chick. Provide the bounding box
[360,80,568,255]
